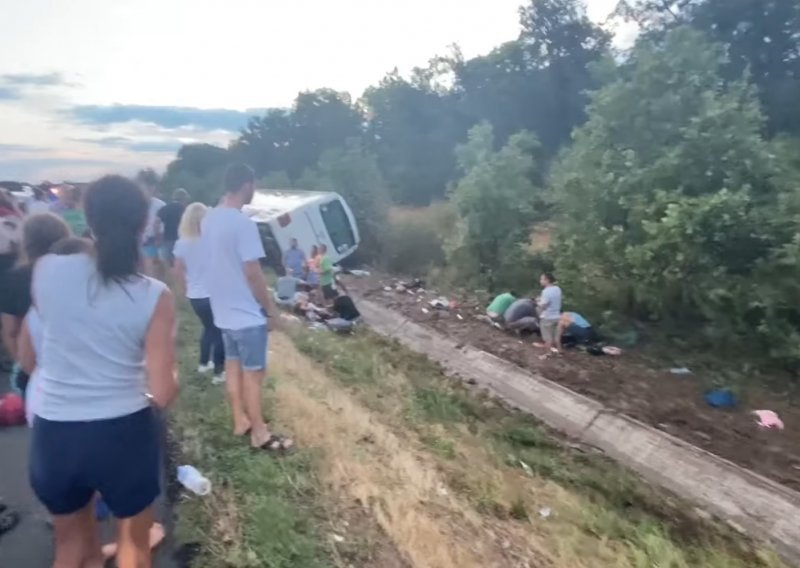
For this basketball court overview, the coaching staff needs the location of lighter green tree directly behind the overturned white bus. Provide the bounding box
[297,139,389,262]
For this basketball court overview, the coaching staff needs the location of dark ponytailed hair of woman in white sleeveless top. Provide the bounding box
[84,175,149,283]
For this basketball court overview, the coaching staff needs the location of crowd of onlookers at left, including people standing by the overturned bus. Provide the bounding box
[0,164,296,568]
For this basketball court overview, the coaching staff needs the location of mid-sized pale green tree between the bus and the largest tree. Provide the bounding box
[448,122,540,289]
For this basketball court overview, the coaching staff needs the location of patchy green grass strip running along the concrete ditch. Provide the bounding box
[291,329,781,568]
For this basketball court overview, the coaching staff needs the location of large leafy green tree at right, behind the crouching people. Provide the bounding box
[551,28,800,360]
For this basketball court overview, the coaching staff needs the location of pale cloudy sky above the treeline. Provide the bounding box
[0,0,616,182]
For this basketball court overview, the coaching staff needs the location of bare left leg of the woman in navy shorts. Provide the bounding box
[53,501,103,568]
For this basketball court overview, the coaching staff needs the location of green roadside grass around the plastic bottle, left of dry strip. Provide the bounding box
[171,307,334,568]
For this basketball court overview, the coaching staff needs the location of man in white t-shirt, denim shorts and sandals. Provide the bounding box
[200,164,292,451]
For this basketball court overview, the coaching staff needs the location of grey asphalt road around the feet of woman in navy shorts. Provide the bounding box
[0,373,177,568]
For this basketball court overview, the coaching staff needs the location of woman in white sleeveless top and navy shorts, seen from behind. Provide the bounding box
[30,176,178,568]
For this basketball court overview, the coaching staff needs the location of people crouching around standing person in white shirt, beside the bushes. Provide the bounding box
[486,273,596,358]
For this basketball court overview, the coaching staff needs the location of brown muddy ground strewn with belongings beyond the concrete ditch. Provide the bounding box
[345,275,800,490]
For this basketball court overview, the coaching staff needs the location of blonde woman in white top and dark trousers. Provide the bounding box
[174,203,225,383]
